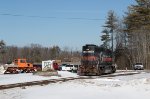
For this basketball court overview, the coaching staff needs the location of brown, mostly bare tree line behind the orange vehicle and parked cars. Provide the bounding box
[0,41,81,63]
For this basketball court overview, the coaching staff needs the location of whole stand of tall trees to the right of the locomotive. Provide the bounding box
[101,0,150,69]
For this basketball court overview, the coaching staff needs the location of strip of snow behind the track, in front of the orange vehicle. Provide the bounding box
[0,71,77,85]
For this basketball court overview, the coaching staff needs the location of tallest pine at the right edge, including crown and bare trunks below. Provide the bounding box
[124,0,150,68]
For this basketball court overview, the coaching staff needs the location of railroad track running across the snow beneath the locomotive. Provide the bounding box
[0,72,140,90]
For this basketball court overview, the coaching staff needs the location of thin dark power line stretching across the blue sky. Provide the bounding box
[0,13,105,21]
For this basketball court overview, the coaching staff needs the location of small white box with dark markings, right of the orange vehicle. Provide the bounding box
[42,60,55,71]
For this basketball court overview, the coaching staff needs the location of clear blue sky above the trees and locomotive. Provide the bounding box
[0,0,135,50]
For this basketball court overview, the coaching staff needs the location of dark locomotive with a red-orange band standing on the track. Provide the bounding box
[78,44,116,75]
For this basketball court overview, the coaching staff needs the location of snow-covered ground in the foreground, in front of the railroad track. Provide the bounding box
[0,72,150,99]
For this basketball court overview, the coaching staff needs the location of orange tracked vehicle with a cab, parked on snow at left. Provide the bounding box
[5,58,36,74]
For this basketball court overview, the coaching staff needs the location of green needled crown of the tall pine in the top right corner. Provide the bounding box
[125,0,150,32]
